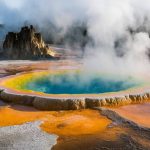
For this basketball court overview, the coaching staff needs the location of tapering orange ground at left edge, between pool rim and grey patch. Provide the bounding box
[0,106,48,126]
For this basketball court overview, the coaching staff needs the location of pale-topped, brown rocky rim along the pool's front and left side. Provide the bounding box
[0,70,150,110]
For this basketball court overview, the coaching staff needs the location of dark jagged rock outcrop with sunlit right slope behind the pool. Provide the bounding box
[3,25,55,59]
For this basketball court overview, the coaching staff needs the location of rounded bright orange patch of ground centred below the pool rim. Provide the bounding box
[41,110,111,136]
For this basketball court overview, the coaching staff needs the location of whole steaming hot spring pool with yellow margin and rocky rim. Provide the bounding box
[0,70,150,110]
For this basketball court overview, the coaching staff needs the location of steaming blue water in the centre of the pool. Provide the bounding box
[23,74,138,94]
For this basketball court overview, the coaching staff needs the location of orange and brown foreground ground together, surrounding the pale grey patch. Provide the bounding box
[0,105,150,150]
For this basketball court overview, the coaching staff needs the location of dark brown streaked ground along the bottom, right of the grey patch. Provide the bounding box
[52,127,150,150]
